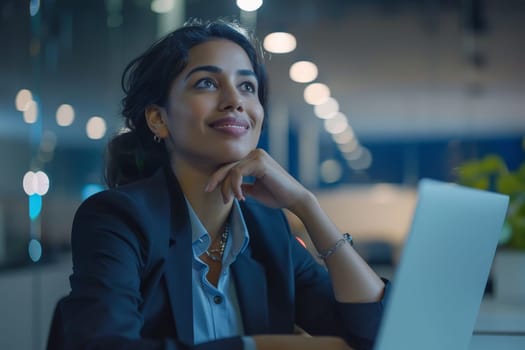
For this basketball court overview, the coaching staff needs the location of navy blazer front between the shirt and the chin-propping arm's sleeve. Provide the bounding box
[234,200,295,334]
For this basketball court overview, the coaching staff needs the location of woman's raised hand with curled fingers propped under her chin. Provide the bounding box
[205,149,311,212]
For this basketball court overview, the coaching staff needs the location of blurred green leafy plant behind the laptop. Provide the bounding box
[456,138,525,250]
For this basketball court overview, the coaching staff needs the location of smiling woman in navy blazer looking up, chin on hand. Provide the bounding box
[61,21,385,350]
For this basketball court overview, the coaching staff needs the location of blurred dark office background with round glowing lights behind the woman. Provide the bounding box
[0,0,525,349]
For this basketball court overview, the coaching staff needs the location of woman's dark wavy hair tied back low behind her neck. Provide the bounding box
[105,20,267,188]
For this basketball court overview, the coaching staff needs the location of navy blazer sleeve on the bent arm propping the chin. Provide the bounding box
[290,211,390,349]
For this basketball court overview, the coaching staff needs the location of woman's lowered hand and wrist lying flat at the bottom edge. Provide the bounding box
[253,335,352,350]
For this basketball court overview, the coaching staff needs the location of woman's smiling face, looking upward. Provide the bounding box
[158,39,264,170]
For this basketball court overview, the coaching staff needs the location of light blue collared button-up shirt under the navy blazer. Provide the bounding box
[186,200,256,350]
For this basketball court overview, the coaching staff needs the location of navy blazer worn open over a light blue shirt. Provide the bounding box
[60,170,383,350]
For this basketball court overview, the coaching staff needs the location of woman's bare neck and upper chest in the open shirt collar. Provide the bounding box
[171,162,233,240]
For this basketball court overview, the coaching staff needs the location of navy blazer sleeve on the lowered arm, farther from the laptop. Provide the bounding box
[60,190,243,350]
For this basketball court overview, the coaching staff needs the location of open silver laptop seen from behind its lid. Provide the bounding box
[374,179,508,350]
